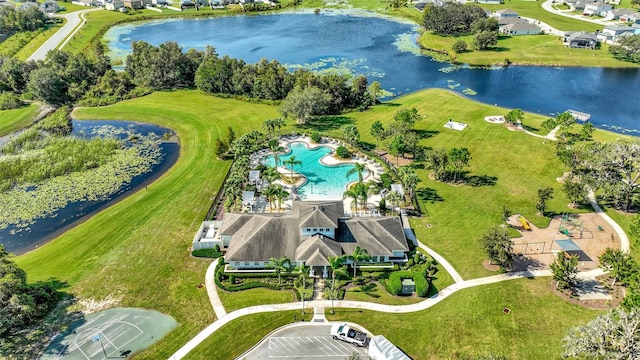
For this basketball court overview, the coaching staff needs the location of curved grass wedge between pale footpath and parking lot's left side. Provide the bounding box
[185,310,313,360]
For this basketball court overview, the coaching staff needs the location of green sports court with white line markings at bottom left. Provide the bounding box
[42,308,178,360]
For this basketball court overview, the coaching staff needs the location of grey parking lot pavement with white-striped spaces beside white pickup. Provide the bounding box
[240,324,369,360]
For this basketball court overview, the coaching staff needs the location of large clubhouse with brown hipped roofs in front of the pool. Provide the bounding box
[205,201,409,277]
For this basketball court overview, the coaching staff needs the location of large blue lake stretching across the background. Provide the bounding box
[105,11,640,135]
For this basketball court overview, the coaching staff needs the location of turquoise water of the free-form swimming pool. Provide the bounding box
[262,142,367,200]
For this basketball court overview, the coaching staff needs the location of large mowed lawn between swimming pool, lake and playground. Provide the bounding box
[349,89,569,278]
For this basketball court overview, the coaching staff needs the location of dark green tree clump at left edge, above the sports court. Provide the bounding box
[0,244,58,336]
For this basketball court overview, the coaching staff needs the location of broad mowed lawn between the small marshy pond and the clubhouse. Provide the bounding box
[16,91,277,359]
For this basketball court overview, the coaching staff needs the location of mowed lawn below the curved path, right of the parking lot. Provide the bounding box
[326,278,601,360]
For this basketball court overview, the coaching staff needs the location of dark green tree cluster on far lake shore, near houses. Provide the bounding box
[422,3,487,36]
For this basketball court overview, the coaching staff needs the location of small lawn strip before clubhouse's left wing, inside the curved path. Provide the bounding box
[218,288,295,312]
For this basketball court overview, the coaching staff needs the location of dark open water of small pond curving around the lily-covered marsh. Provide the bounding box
[0,120,180,254]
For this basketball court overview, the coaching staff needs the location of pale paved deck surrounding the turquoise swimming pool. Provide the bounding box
[250,135,384,216]
